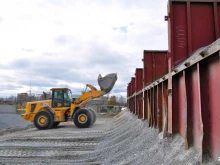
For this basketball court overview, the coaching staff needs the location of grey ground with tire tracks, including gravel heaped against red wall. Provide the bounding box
[0,111,218,165]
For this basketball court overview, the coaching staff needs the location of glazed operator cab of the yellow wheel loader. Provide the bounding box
[51,88,72,108]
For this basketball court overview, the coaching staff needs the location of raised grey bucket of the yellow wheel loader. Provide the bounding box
[98,73,117,93]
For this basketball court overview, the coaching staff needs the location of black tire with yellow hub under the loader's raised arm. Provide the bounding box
[73,109,93,128]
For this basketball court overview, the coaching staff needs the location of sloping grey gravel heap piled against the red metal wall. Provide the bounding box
[84,111,218,165]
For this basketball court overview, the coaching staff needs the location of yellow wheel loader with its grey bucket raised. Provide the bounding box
[21,73,117,129]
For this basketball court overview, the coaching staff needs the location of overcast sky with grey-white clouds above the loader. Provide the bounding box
[0,0,168,97]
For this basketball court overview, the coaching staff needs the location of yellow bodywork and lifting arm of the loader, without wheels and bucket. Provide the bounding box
[21,84,106,122]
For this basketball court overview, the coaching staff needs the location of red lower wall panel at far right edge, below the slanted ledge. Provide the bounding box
[199,53,220,160]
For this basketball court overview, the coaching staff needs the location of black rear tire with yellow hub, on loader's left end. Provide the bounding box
[34,111,54,129]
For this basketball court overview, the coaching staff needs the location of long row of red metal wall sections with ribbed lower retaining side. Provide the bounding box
[128,0,220,160]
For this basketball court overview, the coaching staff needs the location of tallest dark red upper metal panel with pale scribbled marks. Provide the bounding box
[168,0,220,67]
